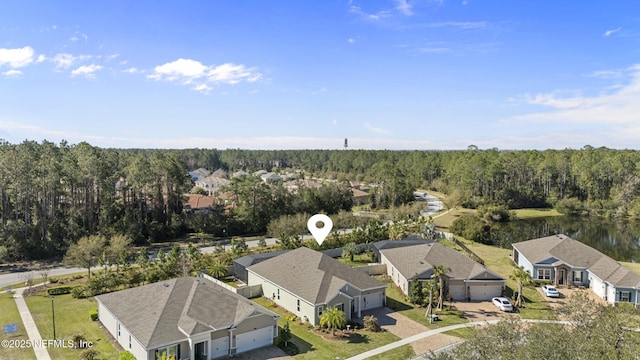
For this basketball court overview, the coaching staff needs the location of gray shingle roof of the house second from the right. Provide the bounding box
[380,242,504,281]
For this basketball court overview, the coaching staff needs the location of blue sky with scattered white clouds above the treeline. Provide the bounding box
[0,0,640,150]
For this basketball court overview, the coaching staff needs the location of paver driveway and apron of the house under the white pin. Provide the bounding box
[362,307,460,354]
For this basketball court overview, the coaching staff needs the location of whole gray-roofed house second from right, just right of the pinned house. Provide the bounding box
[374,240,506,301]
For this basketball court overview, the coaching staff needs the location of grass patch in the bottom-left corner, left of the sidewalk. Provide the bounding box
[0,291,36,360]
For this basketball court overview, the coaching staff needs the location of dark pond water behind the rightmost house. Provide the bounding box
[491,216,640,262]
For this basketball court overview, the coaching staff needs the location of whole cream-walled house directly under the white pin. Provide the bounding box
[247,247,387,325]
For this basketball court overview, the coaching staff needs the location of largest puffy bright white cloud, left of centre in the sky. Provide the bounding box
[147,58,262,93]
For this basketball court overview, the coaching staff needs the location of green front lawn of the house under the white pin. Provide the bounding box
[253,298,415,360]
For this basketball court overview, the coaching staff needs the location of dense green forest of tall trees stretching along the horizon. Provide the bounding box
[0,141,640,260]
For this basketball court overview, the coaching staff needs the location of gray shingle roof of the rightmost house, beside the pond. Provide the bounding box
[512,234,640,288]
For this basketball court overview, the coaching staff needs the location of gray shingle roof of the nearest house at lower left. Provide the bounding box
[96,277,277,349]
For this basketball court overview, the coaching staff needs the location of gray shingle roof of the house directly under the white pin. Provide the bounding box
[248,247,386,304]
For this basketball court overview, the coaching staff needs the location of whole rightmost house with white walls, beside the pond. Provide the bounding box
[512,234,640,304]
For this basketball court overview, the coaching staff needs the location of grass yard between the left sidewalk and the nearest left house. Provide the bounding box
[25,293,120,360]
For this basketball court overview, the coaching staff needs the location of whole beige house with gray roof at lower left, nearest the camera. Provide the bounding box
[96,277,279,360]
